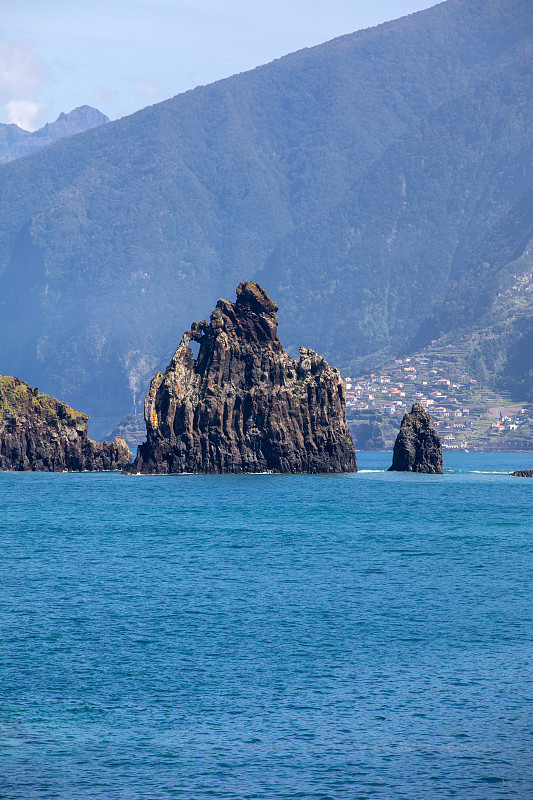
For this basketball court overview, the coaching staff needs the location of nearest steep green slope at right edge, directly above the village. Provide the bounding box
[407,186,533,402]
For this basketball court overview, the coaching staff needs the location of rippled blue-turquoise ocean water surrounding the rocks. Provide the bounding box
[0,453,533,800]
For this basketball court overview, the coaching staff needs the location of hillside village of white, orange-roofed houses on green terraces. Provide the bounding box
[343,351,533,451]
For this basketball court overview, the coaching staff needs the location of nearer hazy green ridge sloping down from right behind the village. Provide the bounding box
[262,59,533,369]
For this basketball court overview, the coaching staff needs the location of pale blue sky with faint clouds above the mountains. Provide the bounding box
[0,0,435,130]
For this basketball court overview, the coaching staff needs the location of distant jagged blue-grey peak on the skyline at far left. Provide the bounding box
[0,106,109,164]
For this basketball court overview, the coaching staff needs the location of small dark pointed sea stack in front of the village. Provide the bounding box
[389,403,442,475]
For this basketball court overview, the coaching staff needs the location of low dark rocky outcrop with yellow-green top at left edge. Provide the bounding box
[0,375,131,472]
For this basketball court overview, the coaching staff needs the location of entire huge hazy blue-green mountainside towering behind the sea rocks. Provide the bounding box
[0,0,533,434]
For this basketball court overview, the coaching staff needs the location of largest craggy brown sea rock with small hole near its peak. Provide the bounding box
[127,282,357,473]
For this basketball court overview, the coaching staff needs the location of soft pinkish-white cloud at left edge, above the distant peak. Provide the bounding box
[0,39,52,102]
